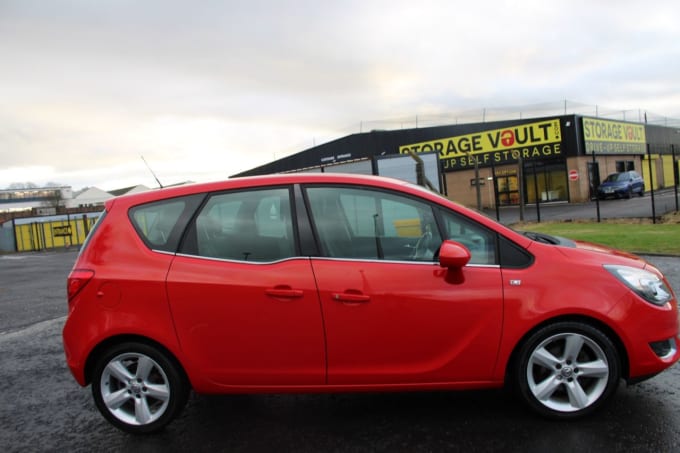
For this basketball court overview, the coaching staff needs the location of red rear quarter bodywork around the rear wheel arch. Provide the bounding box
[64,203,180,384]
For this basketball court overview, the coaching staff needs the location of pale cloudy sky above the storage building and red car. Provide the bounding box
[0,0,680,190]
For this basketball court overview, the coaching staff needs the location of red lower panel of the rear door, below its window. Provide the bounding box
[167,256,326,386]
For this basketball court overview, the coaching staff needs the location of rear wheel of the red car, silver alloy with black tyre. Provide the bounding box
[92,343,189,434]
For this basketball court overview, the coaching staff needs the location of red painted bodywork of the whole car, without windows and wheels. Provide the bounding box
[63,174,680,393]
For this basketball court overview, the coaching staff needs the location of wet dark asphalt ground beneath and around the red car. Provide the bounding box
[0,251,680,452]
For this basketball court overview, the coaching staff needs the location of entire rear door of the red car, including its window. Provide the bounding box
[167,187,326,386]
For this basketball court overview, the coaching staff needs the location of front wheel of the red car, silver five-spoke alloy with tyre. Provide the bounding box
[514,322,621,419]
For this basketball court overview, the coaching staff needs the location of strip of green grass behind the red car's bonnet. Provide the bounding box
[513,213,680,256]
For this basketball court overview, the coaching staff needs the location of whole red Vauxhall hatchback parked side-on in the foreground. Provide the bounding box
[63,174,680,433]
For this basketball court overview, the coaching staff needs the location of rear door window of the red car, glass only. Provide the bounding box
[189,188,295,262]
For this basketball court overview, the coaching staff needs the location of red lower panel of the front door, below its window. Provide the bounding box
[313,259,503,385]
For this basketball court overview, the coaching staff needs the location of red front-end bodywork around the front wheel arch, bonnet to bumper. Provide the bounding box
[495,243,679,379]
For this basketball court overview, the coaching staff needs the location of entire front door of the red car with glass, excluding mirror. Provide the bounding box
[307,187,503,385]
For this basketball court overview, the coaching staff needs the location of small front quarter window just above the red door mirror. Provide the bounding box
[442,211,498,264]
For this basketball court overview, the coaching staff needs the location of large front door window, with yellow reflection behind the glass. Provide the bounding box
[307,187,441,261]
